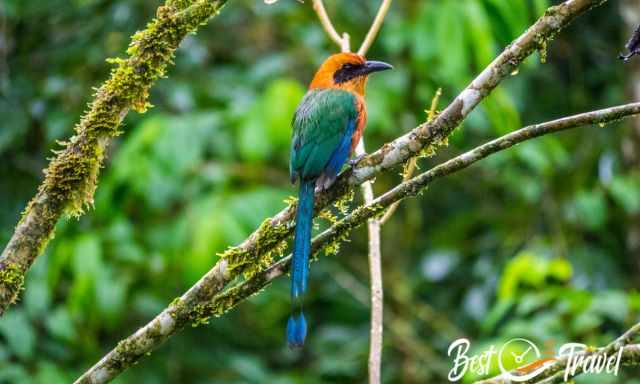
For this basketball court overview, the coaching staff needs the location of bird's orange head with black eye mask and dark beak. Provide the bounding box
[309,52,393,96]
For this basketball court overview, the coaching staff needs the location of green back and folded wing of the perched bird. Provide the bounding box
[289,89,358,182]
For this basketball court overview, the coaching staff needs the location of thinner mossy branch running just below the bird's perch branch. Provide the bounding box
[76,103,640,384]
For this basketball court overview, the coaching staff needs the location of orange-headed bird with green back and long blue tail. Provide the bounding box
[286,52,393,348]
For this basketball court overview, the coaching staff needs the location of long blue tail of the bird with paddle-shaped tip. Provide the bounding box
[287,180,316,348]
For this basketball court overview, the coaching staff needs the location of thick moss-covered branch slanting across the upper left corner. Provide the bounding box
[0,0,226,315]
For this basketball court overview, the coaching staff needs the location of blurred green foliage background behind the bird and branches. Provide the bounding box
[0,0,640,384]
